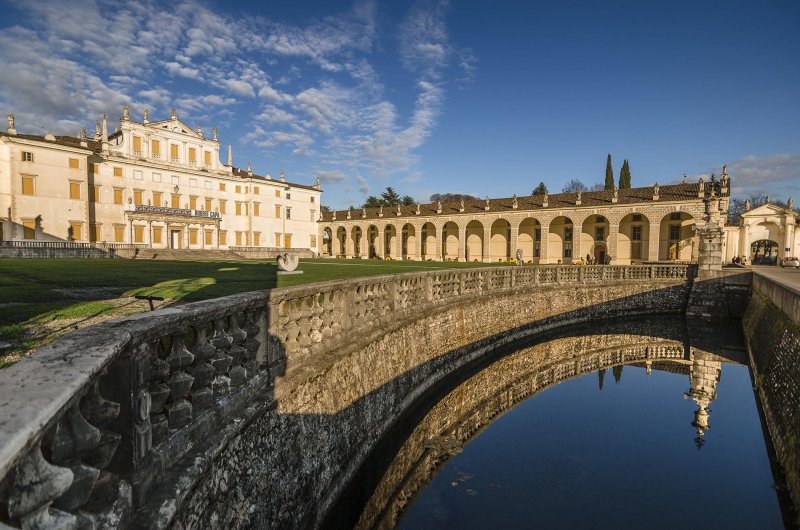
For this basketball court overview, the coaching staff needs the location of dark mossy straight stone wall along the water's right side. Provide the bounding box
[743,273,800,507]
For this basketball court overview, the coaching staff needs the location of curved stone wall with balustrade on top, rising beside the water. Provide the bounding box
[0,266,692,528]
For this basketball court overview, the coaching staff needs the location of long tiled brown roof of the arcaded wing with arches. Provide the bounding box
[322,182,720,222]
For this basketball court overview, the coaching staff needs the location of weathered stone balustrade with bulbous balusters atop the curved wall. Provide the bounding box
[0,265,694,528]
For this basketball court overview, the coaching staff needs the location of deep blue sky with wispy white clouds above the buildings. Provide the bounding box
[0,0,800,208]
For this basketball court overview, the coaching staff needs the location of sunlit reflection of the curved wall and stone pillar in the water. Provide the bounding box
[329,319,744,528]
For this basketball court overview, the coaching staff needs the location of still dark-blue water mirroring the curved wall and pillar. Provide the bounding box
[338,319,781,528]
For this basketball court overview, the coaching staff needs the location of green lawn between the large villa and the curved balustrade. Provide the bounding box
[0,259,500,368]
